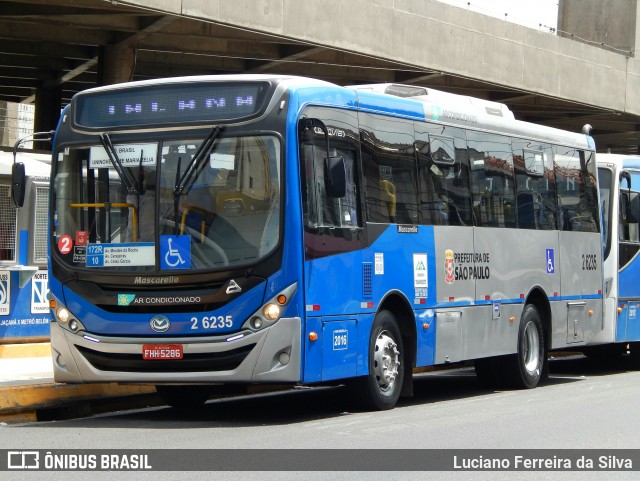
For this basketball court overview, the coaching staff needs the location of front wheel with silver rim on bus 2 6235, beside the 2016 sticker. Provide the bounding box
[348,311,405,411]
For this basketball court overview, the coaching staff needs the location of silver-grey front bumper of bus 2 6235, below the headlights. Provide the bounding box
[51,317,301,384]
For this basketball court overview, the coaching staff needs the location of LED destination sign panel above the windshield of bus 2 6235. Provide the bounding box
[74,82,269,129]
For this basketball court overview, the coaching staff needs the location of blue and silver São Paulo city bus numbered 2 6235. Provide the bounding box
[42,75,603,409]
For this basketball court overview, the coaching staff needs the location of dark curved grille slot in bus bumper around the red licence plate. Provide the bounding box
[76,344,255,372]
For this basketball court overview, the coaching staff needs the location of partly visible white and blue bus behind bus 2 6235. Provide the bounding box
[585,154,640,366]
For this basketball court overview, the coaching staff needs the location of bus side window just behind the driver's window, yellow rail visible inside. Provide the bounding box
[358,113,418,224]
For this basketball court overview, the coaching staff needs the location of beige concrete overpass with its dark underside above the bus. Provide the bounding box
[0,0,640,153]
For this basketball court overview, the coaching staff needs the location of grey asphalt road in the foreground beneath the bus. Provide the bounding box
[0,352,640,481]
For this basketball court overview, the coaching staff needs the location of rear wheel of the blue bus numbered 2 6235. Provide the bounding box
[503,304,546,389]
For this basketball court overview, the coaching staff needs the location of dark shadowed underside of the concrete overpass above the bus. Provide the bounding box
[0,0,640,154]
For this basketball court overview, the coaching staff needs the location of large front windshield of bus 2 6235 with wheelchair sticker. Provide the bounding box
[52,135,280,273]
